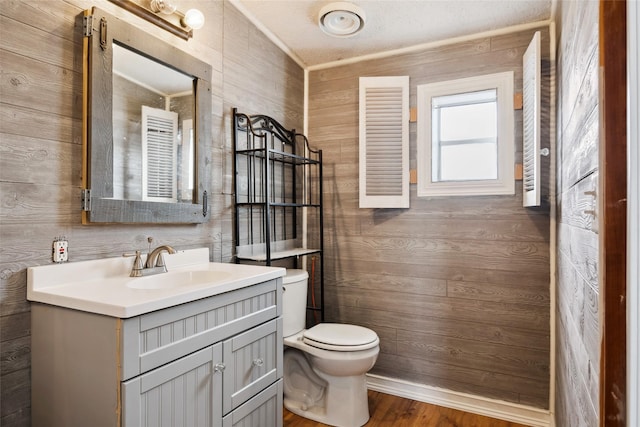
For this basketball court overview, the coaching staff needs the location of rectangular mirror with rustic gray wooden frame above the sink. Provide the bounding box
[82,8,211,223]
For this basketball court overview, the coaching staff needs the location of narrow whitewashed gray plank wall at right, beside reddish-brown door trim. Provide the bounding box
[555,1,600,426]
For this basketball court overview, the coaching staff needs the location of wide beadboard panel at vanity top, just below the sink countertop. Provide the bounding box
[121,279,281,380]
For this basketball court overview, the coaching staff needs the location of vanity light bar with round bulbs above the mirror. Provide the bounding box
[109,0,204,40]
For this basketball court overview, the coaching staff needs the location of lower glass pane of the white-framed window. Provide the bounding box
[434,142,498,181]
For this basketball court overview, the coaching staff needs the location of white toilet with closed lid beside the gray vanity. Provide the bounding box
[282,270,380,427]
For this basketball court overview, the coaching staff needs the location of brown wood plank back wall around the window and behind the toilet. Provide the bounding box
[308,28,550,408]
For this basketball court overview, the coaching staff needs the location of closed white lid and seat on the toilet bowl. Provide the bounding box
[304,323,380,351]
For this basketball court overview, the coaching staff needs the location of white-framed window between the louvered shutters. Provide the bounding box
[417,72,515,197]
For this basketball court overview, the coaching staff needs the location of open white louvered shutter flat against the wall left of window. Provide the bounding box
[359,76,409,208]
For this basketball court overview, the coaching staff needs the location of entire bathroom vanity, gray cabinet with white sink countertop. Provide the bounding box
[27,249,285,427]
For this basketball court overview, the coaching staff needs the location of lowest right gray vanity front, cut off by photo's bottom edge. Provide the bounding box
[222,380,282,427]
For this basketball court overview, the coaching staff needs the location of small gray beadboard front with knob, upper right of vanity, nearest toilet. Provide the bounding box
[222,318,283,414]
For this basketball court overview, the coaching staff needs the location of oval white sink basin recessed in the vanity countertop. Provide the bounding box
[127,270,231,289]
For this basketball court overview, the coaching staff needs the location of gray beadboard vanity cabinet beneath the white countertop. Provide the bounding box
[32,279,283,427]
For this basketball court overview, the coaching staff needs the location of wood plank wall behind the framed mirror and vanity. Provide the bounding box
[0,0,304,427]
